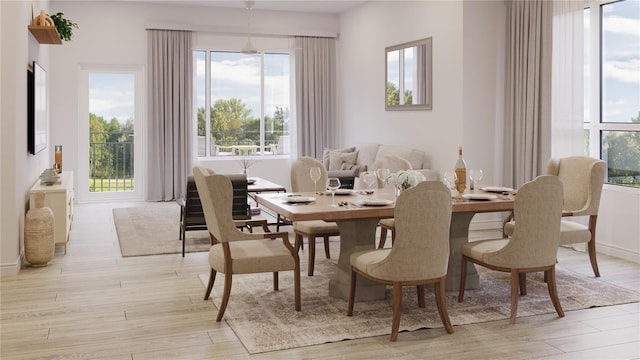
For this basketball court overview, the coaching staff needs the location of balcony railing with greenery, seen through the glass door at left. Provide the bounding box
[89,131,134,192]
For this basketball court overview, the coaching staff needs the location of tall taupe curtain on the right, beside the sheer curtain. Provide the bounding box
[504,0,552,188]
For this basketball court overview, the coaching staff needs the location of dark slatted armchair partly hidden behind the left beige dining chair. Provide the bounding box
[177,174,269,257]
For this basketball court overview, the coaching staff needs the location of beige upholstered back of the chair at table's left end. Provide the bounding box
[193,166,242,242]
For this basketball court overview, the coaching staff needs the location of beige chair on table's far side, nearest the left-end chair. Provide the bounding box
[291,156,340,276]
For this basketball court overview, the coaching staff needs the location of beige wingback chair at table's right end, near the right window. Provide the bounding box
[504,156,606,277]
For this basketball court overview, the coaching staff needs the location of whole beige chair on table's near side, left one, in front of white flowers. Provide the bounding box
[347,181,453,341]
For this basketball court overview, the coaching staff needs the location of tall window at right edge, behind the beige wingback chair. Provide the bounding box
[584,0,640,187]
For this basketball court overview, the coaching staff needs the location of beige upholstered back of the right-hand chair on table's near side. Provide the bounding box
[487,175,563,268]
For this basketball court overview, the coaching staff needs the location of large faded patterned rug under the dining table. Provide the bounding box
[200,259,640,354]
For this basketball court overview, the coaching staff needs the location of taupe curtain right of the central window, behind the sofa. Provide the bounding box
[294,37,336,159]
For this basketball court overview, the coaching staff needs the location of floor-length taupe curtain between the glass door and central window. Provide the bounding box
[147,30,193,201]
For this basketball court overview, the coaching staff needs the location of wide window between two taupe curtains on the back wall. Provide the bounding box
[194,50,290,157]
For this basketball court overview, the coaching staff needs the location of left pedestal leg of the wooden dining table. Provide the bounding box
[329,219,386,301]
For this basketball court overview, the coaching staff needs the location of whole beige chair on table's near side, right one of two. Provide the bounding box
[458,175,564,324]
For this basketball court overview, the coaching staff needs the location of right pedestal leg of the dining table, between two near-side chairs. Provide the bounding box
[445,213,480,291]
